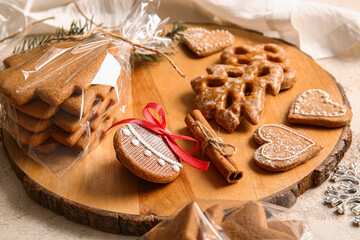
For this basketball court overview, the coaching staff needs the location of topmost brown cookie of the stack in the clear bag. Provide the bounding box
[0,40,118,106]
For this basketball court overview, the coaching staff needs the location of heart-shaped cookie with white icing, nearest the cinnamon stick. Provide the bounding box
[254,124,322,172]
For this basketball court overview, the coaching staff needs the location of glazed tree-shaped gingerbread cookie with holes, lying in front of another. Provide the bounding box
[191,62,283,132]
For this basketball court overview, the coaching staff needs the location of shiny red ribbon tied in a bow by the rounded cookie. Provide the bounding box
[101,103,209,171]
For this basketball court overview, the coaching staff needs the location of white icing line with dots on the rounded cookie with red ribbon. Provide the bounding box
[123,123,183,172]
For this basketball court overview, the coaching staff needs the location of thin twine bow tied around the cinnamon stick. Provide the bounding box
[196,121,237,158]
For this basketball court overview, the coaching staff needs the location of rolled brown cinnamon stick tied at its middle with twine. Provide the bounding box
[185,110,243,183]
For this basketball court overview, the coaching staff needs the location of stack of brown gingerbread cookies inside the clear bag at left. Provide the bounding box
[0,40,120,154]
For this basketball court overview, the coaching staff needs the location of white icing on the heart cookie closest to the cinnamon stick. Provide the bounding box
[259,124,315,161]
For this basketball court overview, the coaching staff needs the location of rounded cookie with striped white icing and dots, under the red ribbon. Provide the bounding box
[114,123,182,183]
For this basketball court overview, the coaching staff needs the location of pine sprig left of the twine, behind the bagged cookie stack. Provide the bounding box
[13,18,93,54]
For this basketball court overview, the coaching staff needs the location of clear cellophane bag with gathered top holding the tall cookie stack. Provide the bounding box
[0,1,171,175]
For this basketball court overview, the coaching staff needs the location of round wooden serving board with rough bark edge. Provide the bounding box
[3,25,351,235]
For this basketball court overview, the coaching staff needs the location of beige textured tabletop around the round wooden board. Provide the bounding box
[0,0,360,240]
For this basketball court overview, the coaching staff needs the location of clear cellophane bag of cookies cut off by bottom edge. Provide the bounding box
[140,199,313,240]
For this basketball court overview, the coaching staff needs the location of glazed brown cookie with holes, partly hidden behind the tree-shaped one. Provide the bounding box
[220,43,296,90]
